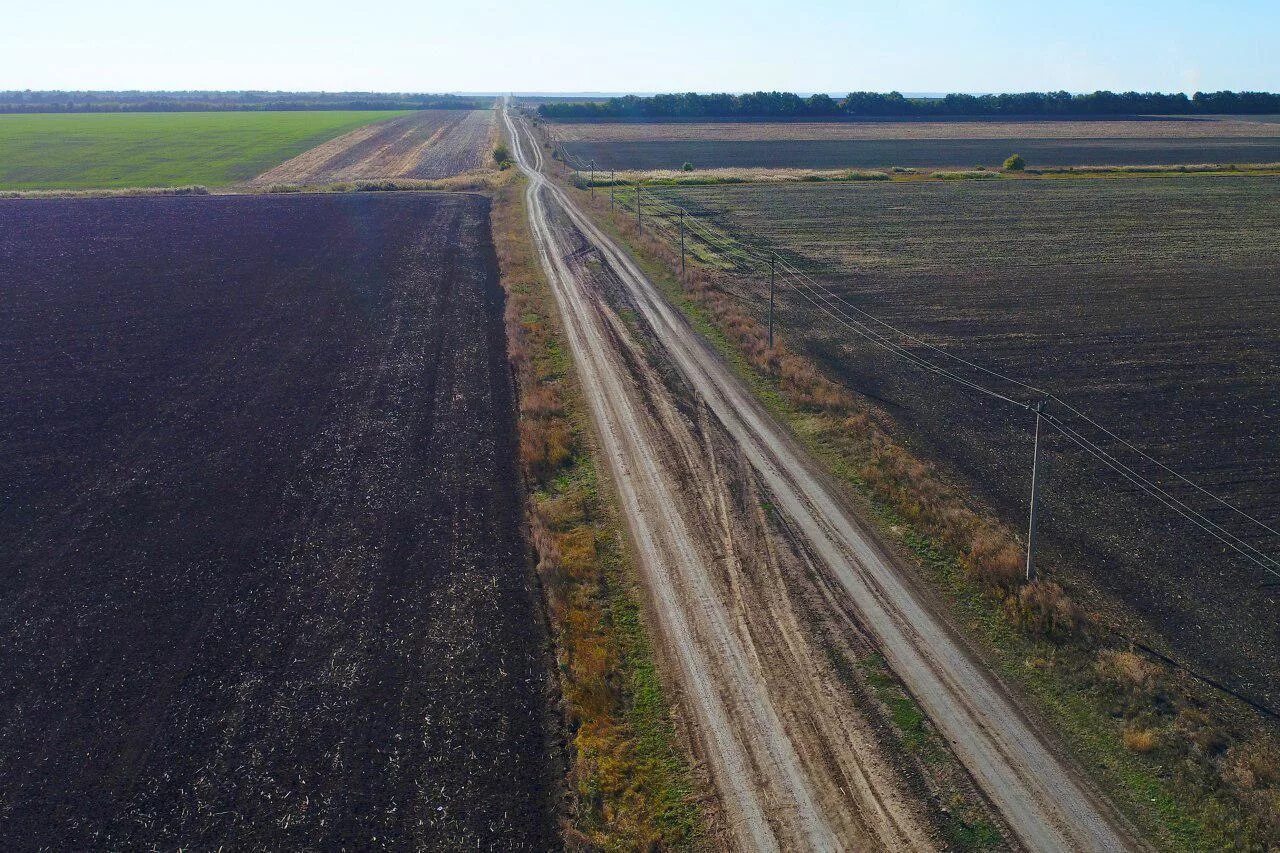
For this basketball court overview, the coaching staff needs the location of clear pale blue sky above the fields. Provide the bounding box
[0,0,1280,92]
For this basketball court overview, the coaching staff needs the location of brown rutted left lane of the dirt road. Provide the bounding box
[513,106,937,850]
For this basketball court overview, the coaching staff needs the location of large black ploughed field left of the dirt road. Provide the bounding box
[0,193,556,850]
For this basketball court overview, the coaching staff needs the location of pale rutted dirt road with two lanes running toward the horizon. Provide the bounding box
[504,106,1140,850]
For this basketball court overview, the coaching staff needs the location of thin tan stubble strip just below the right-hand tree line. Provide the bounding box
[547,115,1280,142]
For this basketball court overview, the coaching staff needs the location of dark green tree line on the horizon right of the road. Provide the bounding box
[538,91,1280,119]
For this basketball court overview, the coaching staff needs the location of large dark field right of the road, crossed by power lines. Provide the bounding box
[655,177,1280,707]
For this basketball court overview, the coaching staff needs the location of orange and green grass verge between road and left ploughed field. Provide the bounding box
[493,172,703,850]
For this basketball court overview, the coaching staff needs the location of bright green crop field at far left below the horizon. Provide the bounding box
[0,110,403,190]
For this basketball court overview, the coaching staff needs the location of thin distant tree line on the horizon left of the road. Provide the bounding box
[0,90,493,113]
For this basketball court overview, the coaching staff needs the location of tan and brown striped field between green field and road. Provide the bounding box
[252,110,494,186]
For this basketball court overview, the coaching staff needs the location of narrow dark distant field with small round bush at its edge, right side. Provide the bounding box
[562,137,1280,170]
